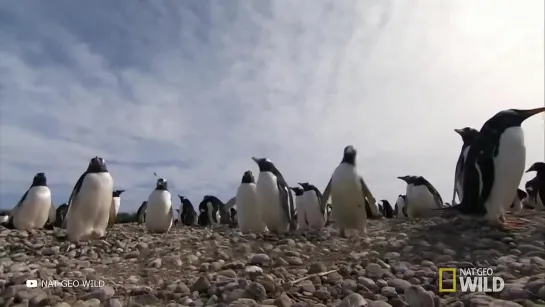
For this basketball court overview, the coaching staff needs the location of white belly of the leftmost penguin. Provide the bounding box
[13,186,51,230]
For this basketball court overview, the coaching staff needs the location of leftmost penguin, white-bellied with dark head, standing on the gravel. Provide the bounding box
[5,173,51,230]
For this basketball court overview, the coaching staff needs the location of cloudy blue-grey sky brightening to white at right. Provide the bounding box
[0,0,545,211]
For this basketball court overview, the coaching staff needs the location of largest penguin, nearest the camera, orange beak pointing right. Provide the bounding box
[446,107,545,228]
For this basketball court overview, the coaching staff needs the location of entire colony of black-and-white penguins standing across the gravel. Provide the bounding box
[0,107,545,242]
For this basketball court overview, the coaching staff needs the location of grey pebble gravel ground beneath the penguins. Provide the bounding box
[0,211,545,307]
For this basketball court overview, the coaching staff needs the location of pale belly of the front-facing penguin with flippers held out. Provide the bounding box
[331,164,367,232]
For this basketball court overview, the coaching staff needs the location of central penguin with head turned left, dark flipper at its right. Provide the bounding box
[252,157,296,233]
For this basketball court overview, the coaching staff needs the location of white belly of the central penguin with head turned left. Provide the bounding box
[256,172,289,232]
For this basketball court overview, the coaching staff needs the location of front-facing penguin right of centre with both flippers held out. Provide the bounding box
[322,145,380,237]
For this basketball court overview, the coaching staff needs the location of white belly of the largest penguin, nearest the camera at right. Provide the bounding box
[485,127,526,221]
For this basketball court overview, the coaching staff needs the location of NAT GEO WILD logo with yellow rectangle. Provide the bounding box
[438,268,505,293]
